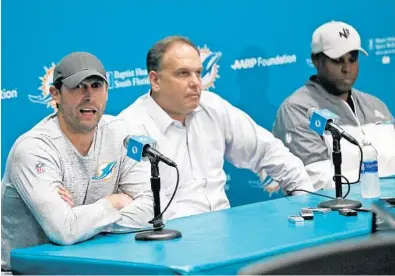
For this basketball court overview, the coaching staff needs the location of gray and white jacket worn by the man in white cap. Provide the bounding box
[273,76,395,188]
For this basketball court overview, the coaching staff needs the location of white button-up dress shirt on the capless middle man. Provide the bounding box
[118,91,314,219]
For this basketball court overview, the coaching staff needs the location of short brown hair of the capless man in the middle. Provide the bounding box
[147,36,200,72]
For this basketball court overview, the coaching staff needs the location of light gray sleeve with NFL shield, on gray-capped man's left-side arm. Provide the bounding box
[10,137,121,245]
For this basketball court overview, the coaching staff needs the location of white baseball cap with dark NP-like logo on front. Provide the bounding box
[311,21,368,59]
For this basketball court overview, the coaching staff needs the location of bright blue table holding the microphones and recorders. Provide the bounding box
[11,179,395,274]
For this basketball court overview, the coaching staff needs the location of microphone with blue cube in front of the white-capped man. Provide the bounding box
[307,107,359,146]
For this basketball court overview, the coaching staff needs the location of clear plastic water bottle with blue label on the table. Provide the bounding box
[360,141,380,198]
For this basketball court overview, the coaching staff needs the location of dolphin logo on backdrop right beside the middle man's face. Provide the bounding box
[198,45,222,89]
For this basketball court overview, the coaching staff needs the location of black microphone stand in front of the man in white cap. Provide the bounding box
[318,133,362,210]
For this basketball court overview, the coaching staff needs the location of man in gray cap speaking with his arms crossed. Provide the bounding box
[1,52,153,270]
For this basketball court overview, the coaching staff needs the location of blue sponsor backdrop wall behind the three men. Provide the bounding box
[1,0,395,206]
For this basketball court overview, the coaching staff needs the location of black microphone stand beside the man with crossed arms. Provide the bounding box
[135,156,181,241]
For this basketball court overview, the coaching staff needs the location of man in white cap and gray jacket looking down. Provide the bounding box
[273,21,395,189]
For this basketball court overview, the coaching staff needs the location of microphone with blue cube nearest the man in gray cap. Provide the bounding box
[123,135,177,167]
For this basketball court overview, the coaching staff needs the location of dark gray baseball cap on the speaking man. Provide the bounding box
[53,52,107,88]
